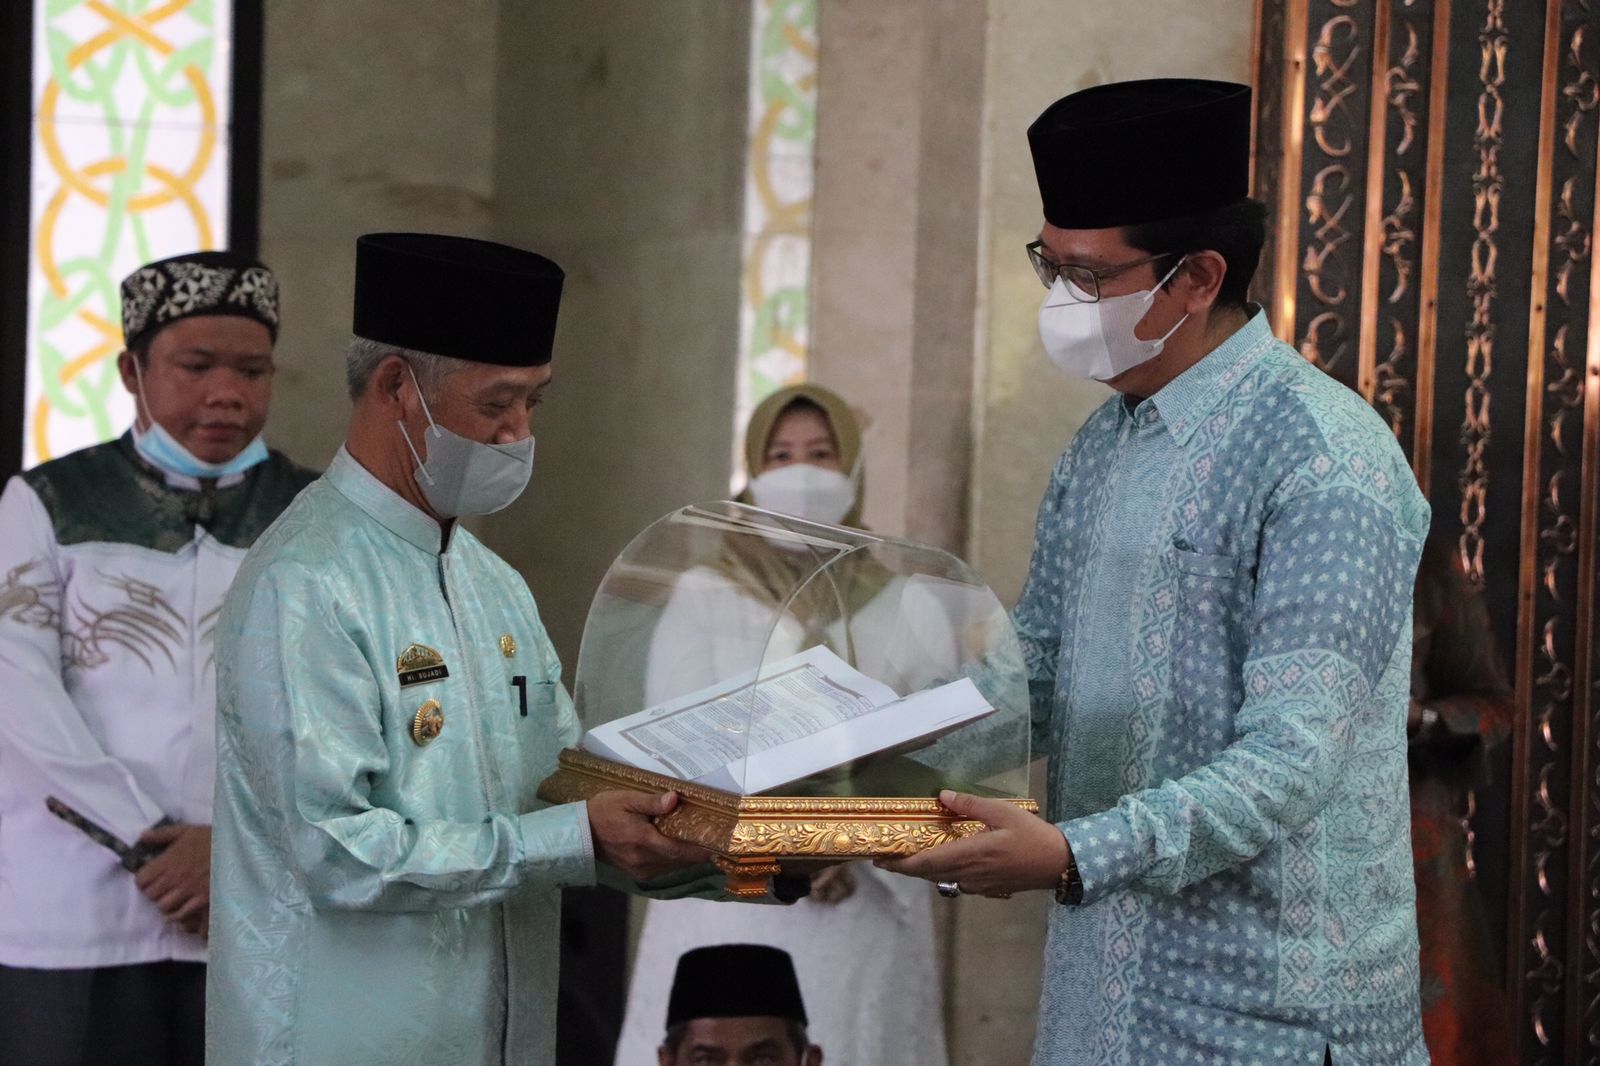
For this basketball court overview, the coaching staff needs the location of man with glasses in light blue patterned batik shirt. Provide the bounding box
[894,80,1427,1066]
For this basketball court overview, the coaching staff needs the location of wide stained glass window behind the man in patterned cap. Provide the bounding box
[22,0,234,466]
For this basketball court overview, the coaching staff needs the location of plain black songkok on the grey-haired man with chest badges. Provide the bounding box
[354,234,566,367]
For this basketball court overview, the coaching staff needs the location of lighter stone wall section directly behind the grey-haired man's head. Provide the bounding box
[261,0,496,467]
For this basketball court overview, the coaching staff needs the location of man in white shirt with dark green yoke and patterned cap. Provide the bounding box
[0,251,315,1066]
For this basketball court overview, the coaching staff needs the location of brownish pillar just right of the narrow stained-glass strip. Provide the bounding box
[811,0,984,551]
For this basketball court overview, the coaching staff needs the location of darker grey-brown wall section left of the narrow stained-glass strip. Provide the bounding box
[480,0,749,665]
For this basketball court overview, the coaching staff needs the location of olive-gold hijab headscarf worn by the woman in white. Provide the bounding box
[715,383,894,632]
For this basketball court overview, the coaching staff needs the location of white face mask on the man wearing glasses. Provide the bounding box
[1038,259,1189,381]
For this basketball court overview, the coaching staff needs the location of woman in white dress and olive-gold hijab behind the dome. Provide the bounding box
[604,384,947,1066]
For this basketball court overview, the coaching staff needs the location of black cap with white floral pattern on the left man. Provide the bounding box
[122,251,278,347]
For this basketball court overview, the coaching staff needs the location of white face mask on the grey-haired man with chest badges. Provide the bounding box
[395,365,533,519]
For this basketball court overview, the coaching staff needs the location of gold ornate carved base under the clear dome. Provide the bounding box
[539,747,1038,898]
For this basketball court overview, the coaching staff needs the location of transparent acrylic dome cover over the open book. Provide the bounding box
[574,503,1029,797]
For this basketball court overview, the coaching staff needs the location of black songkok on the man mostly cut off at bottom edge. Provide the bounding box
[667,944,806,1029]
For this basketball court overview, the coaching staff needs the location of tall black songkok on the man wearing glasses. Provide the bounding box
[1027,78,1250,229]
